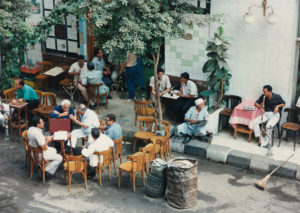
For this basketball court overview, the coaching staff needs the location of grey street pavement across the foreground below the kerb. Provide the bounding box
[0,135,300,213]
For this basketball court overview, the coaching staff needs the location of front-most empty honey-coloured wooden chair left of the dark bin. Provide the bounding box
[118,152,145,192]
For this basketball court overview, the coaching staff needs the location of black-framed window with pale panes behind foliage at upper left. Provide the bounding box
[42,0,80,57]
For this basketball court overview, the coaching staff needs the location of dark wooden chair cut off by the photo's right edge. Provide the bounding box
[278,108,300,151]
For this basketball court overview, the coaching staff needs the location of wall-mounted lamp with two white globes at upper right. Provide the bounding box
[244,0,278,24]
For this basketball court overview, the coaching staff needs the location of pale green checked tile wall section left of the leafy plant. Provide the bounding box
[165,26,209,80]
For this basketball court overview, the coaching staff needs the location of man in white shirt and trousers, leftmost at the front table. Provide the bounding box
[27,115,62,176]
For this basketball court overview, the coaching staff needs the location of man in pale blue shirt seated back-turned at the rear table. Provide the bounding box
[82,62,109,107]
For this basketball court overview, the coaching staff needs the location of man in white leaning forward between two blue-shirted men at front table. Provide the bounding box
[71,104,100,148]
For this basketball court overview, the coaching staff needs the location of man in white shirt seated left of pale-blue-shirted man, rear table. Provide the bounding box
[69,55,88,101]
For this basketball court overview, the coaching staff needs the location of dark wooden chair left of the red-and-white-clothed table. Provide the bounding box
[218,95,242,132]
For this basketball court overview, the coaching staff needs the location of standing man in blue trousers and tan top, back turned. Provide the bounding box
[120,52,137,103]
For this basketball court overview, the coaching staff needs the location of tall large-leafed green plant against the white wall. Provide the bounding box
[202,27,232,107]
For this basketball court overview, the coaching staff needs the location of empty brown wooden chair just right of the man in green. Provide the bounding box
[37,92,57,120]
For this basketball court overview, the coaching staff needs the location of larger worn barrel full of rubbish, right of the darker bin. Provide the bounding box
[166,159,198,209]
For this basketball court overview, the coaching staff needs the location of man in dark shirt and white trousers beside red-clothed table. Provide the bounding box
[253,85,285,146]
